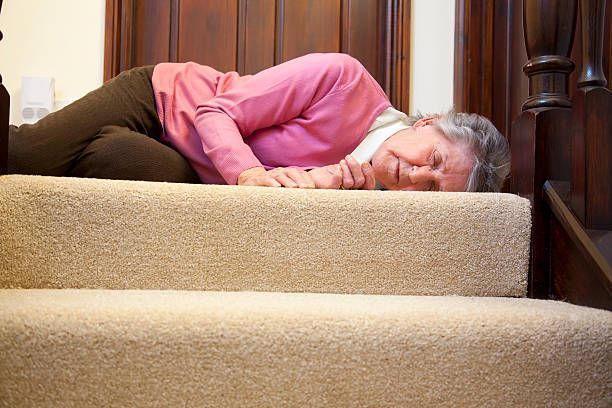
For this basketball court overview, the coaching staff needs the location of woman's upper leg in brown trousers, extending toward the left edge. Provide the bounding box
[8,66,162,176]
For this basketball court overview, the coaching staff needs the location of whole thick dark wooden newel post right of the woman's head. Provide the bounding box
[511,0,577,298]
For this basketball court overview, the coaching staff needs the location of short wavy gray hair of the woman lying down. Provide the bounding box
[409,110,510,192]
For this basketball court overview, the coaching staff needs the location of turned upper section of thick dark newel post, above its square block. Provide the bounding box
[522,0,577,110]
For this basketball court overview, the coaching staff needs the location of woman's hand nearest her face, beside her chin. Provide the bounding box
[309,156,376,190]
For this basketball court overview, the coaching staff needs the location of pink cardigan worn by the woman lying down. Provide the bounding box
[153,54,391,184]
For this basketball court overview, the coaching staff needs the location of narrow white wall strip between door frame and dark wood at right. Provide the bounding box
[410,0,455,114]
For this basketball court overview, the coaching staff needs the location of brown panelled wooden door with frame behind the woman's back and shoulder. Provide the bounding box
[104,0,410,112]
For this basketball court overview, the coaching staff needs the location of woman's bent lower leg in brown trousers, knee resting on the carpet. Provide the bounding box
[67,126,200,183]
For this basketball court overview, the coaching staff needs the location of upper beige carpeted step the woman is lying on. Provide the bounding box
[0,176,530,296]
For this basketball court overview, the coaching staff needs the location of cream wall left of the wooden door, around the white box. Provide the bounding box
[0,0,105,123]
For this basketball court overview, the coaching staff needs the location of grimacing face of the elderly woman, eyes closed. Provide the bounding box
[372,118,474,191]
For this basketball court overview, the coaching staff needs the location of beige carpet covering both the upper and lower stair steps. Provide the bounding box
[0,176,612,407]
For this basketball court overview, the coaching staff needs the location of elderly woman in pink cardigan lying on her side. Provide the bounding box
[8,54,510,191]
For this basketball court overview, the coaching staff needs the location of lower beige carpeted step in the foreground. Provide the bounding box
[0,289,612,407]
